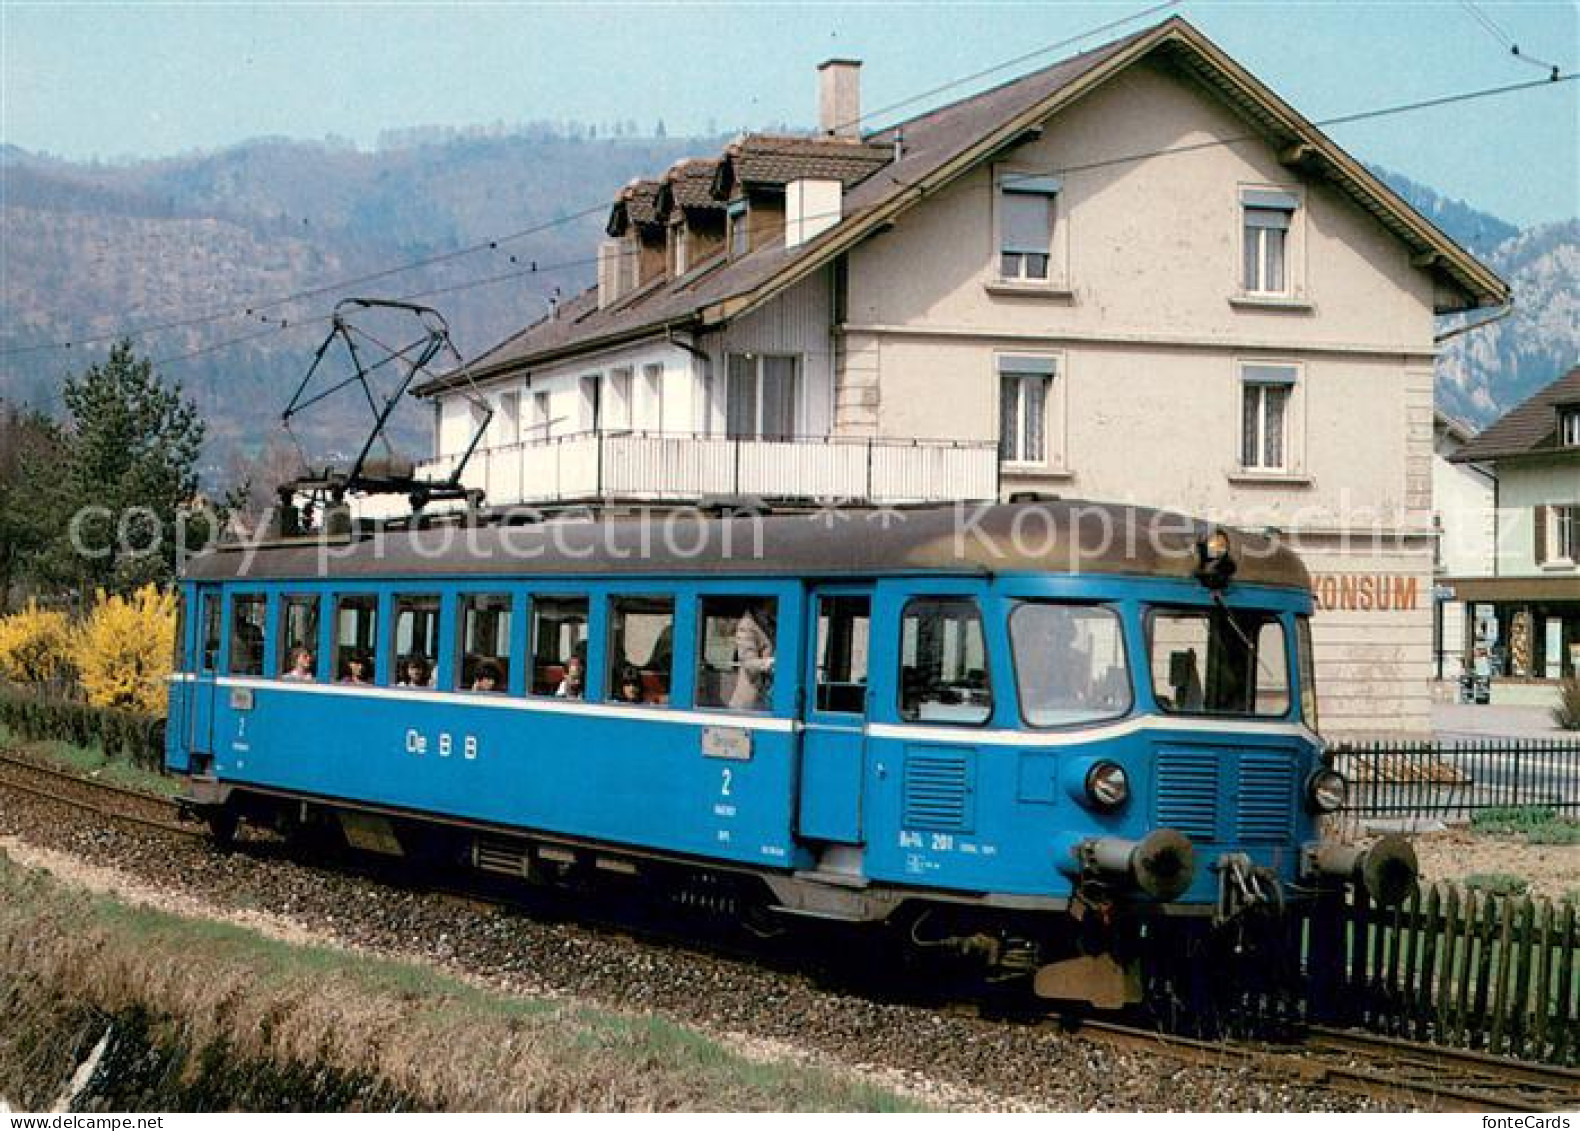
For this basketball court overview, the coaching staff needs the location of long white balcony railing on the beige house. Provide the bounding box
[417,431,999,507]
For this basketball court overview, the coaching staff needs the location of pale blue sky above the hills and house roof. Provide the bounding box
[0,0,1580,224]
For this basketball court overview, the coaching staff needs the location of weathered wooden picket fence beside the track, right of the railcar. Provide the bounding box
[1305,885,1580,1065]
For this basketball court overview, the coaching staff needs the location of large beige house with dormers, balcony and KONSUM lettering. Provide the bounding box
[404,19,1509,733]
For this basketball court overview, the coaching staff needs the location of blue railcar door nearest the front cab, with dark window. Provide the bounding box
[796,586,872,845]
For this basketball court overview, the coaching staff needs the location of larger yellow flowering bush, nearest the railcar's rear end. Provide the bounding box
[74,584,175,714]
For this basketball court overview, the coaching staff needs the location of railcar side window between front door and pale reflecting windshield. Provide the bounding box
[899,597,992,723]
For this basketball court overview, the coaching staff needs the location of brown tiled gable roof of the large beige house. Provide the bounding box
[429,17,1507,395]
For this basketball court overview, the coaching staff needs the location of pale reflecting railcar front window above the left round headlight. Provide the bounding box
[1010,602,1133,727]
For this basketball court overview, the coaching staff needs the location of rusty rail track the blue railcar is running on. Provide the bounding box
[0,752,1580,1112]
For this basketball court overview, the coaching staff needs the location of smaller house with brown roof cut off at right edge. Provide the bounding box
[1444,366,1580,703]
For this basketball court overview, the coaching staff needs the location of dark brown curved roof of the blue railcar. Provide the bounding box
[186,501,1310,588]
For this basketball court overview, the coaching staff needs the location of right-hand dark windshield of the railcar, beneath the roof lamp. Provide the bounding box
[1149,605,1289,717]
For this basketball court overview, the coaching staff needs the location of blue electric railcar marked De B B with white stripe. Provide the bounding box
[167,502,1414,1005]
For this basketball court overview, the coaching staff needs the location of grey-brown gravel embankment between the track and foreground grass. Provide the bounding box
[0,791,1403,1110]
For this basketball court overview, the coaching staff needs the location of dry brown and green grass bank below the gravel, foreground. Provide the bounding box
[0,853,916,1110]
